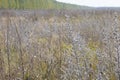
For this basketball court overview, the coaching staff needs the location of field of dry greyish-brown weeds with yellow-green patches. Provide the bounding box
[0,10,120,80]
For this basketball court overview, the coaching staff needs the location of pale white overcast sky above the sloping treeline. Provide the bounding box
[56,0,120,7]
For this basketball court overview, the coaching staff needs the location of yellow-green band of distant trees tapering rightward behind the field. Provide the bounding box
[0,0,81,9]
